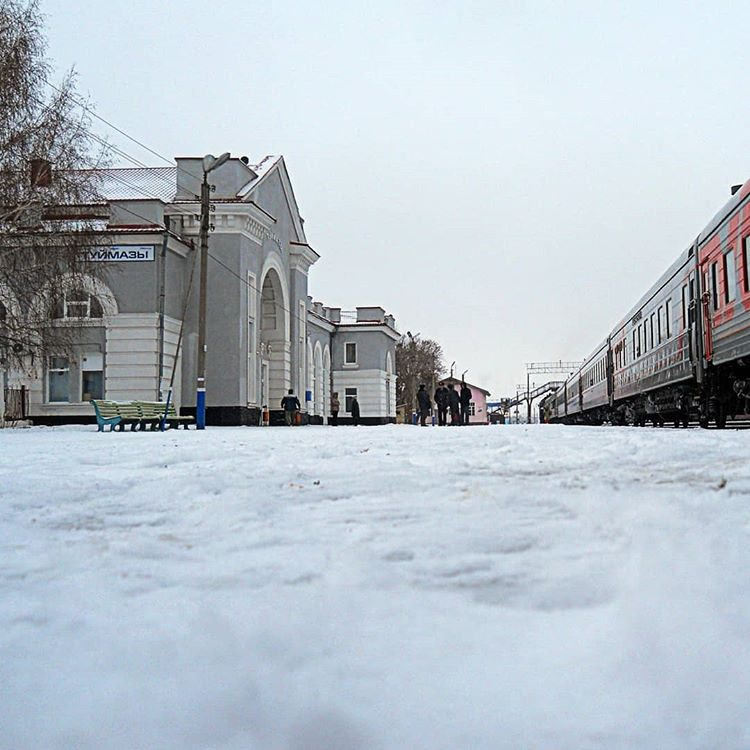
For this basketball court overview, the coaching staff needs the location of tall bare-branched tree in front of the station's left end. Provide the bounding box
[0,0,107,370]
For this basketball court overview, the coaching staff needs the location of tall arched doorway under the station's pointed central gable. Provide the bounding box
[259,268,290,409]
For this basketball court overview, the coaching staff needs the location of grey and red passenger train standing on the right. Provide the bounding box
[540,180,750,427]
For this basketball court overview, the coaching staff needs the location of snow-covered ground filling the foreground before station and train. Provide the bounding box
[0,426,750,750]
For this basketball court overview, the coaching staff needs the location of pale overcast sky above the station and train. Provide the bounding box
[42,0,750,396]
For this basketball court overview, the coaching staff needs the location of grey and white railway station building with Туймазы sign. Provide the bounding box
[2,156,399,425]
